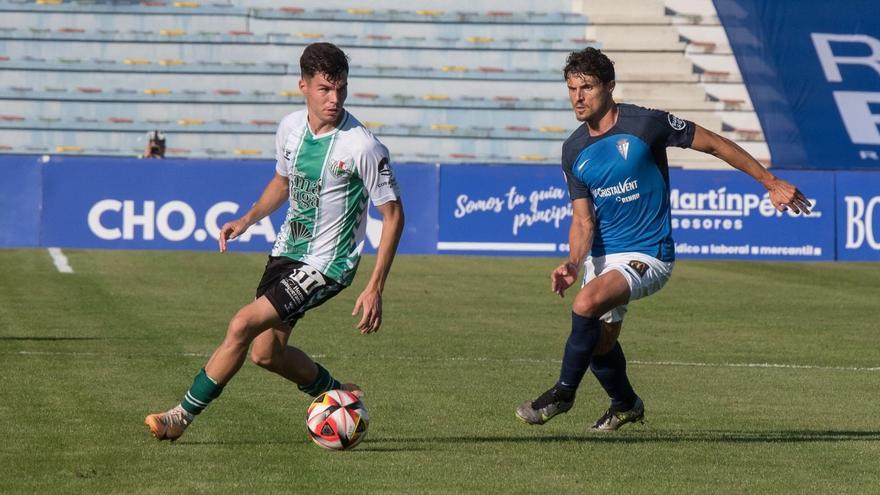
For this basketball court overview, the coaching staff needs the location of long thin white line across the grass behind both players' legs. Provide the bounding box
[8,351,880,372]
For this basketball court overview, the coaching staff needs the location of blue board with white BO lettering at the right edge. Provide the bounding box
[837,172,880,261]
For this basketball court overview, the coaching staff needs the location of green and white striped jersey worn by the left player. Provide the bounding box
[272,109,400,285]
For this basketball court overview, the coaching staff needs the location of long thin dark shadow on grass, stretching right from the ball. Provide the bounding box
[371,429,880,444]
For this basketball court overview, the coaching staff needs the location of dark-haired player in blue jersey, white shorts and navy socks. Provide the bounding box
[516,48,811,431]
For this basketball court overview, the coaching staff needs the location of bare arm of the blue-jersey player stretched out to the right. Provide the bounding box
[691,125,812,215]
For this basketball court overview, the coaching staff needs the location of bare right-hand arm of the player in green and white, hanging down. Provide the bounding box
[351,199,404,334]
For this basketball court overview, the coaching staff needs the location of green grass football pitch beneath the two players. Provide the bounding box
[0,250,880,494]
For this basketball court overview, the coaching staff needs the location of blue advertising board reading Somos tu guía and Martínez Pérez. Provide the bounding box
[437,165,835,261]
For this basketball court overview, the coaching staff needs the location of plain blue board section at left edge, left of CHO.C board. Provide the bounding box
[0,155,43,247]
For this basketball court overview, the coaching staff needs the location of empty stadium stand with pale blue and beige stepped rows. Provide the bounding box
[0,0,770,167]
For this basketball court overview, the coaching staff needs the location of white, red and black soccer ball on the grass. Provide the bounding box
[306,390,370,450]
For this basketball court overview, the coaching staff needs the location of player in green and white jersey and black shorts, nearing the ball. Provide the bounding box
[145,43,404,440]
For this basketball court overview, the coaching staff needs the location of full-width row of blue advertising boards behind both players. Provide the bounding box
[0,156,868,261]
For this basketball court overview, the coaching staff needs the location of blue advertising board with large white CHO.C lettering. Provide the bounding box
[33,157,439,253]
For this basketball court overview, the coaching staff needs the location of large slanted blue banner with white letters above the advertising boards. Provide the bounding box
[714,0,880,169]
